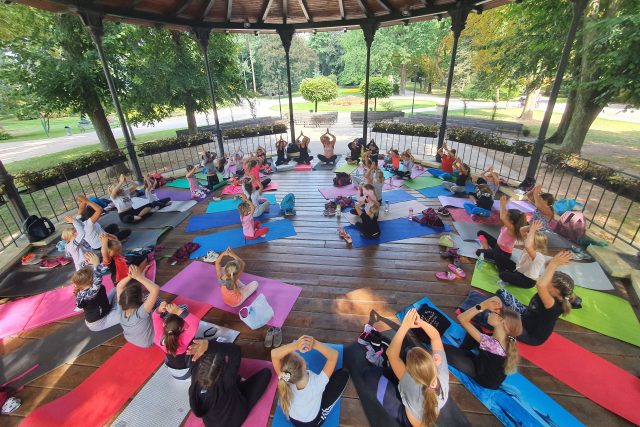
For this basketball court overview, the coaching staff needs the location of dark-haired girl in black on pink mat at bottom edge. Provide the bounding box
[187,340,272,427]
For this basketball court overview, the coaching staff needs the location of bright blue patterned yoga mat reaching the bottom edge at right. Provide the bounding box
[396,297,583,427]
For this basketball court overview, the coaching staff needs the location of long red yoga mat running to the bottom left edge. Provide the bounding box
[21,297,211,427]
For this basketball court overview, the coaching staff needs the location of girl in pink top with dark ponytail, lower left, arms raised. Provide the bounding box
[153,301,200,369]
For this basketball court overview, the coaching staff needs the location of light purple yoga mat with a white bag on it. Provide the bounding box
[162,261,302,328]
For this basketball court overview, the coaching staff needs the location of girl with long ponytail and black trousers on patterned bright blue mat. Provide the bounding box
[444,297,522,389]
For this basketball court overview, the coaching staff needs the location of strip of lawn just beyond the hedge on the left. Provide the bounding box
[5,129,176,174]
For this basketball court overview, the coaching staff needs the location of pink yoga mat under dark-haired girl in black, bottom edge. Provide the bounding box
[184,359,278,427]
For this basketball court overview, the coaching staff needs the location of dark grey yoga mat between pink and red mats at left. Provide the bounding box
[0,319,122,388]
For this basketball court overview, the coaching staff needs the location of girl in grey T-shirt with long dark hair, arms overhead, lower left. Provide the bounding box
[116,265,160,347]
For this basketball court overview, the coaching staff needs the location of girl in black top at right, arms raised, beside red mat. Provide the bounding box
[496,251,577,345]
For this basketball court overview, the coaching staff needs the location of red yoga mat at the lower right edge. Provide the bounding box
[518,333,640,425]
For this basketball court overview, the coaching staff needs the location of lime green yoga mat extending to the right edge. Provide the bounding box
[471,262,640,347]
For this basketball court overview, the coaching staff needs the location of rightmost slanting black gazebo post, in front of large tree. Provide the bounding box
[527,0,587,178]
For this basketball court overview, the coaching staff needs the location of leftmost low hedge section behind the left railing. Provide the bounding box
[15,150,127,190]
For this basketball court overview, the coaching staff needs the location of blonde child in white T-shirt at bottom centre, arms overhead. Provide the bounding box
[271,335,349,427]
